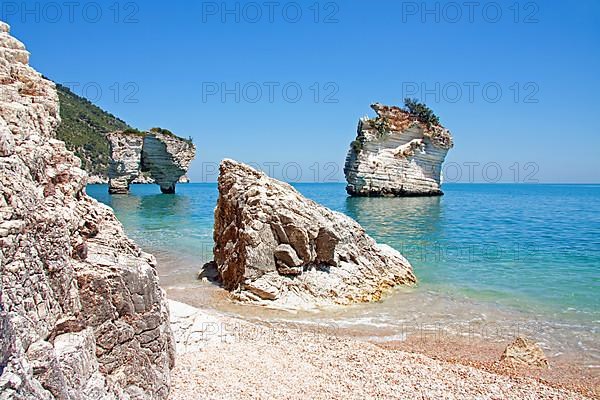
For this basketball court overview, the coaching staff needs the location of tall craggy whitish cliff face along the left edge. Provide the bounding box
[0,23,174,400]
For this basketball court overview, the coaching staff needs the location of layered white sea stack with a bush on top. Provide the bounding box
[344,103,453,196]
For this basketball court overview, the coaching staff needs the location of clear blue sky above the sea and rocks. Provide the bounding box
[0,0,600,182]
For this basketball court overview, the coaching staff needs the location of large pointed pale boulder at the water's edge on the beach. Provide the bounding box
[209,160,415,308]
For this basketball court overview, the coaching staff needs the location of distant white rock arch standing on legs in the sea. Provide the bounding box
[107,129,196,194]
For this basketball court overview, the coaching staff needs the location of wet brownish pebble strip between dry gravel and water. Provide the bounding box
[163,287,600,399]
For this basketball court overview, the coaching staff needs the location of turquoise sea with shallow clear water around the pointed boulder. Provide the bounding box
[87,183,600,372]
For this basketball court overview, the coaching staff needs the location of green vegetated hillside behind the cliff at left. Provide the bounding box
[56,84,132,176]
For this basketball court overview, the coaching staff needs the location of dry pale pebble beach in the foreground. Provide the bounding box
[170,302,587,400]
